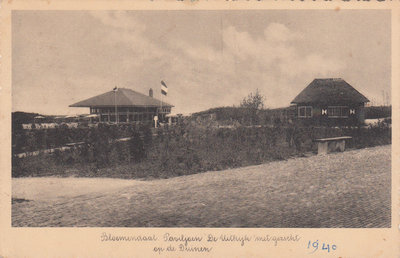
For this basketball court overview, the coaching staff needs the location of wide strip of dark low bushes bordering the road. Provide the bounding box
[13,121,391,178]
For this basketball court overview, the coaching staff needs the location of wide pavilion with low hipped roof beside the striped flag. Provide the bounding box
[70,88,173,122]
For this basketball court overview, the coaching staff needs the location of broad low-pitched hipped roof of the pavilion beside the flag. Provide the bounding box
[70,88,173,107]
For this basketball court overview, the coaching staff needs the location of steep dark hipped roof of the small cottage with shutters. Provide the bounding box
[291,78,369,104]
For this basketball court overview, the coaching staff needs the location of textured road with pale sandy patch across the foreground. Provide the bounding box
[12,145,391,227]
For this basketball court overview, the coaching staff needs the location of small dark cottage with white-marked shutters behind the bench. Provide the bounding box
[291,78,369,126]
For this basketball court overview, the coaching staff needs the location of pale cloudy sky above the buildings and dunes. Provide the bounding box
[12,10,391,115]
